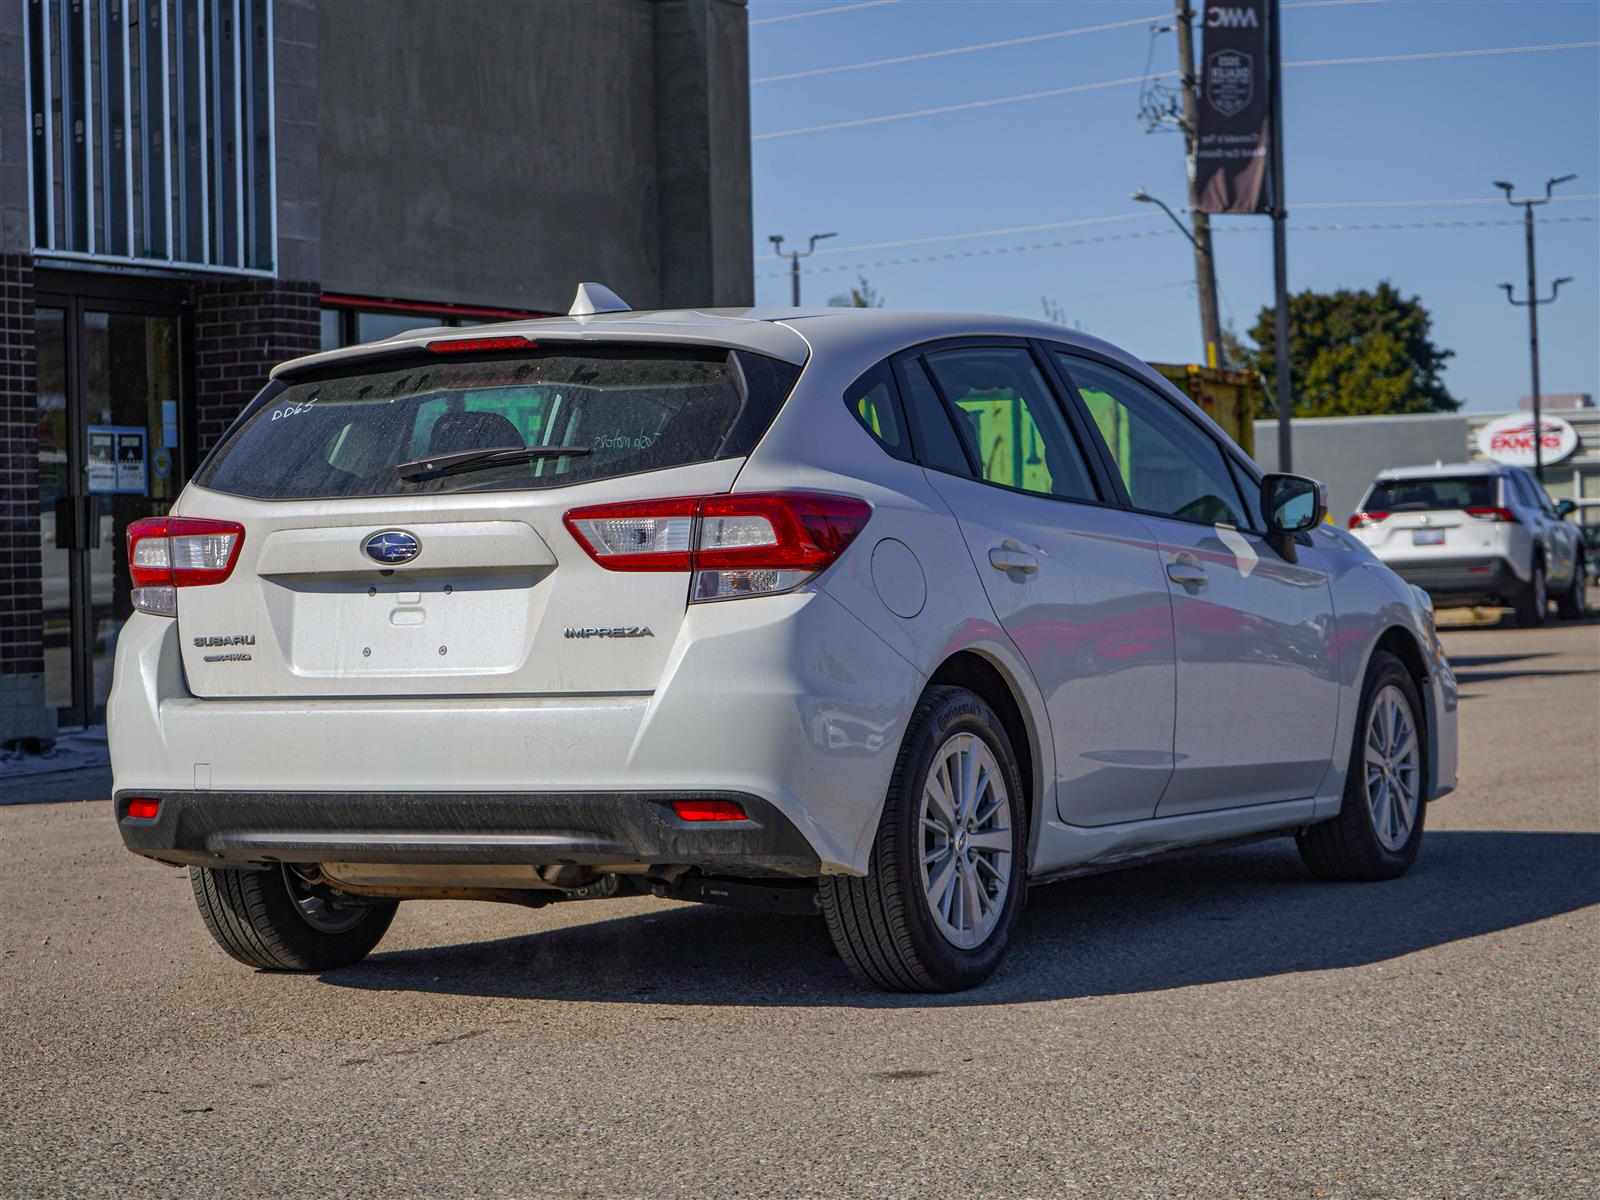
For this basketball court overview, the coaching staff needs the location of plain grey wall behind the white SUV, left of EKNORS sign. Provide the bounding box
[1256,413,1467,525]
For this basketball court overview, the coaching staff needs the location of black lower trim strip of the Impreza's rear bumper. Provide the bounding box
[114,790,821,878]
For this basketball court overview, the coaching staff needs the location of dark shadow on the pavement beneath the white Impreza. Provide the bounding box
[322,830,1600,1008]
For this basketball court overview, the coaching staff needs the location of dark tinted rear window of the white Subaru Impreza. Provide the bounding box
[195,347,798,499]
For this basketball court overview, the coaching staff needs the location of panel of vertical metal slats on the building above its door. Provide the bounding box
[21,0,277,274]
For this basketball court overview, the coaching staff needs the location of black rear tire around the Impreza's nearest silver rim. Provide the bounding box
[819,686,1029,992]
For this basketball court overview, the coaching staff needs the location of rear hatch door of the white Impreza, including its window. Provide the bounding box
[178,344,798,698]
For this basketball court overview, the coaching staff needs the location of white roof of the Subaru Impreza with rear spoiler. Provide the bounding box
[272,309,1150,376]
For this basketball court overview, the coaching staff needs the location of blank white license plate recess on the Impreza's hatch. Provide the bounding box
[267,573,534,678]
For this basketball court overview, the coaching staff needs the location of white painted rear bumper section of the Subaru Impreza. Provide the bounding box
[107,592,923,875]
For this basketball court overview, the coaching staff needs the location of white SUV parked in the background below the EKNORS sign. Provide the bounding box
[1350,462,1586,626]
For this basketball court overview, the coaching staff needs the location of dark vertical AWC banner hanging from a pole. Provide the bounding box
[1195,0,1272,213]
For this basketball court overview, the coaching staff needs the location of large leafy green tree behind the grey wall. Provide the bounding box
[1242,280,1461,416]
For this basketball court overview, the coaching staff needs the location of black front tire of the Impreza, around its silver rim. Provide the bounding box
[1294,650,1432,880]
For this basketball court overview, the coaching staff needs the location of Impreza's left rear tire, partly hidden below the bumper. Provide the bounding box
[189,867,400,971]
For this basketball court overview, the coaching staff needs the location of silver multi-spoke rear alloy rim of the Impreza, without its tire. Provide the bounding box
[917,733,1014,950]
